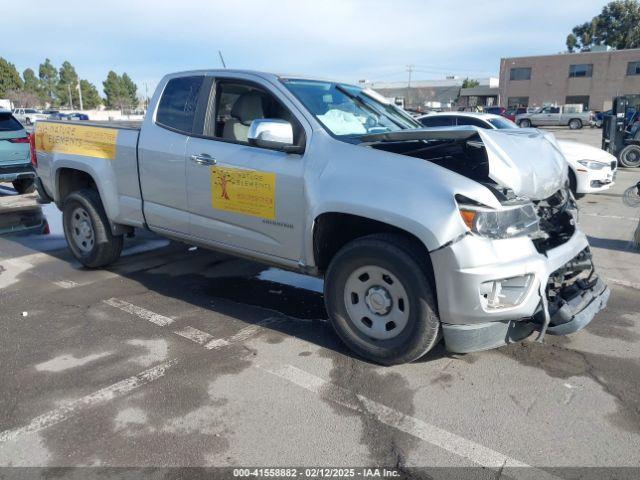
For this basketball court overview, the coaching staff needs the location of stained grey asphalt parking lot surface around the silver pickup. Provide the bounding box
[0,129,640,478]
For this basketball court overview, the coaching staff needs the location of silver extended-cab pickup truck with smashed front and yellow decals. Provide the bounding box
[34,70,609,364]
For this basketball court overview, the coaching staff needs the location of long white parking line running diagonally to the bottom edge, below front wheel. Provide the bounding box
[259,365,558,480]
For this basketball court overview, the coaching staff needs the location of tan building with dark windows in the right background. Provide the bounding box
[499,49,640,110]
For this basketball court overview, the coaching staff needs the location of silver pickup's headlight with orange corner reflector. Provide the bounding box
[459,203,540,239]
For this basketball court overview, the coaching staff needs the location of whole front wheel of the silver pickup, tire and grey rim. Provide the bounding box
[324,234,440,365]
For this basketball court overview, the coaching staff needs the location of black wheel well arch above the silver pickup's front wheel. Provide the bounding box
[313,212,432,272]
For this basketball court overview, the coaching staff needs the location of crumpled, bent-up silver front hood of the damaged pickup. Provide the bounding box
[470,128,568,200]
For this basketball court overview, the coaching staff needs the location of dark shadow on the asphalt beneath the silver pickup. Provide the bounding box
[113,246,446,361]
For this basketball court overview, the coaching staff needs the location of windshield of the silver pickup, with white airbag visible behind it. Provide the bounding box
[284,79,422,137]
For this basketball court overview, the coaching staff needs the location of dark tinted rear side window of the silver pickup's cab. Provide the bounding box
[156,76,204,134]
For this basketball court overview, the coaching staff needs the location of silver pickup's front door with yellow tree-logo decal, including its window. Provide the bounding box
[186,78,306,261]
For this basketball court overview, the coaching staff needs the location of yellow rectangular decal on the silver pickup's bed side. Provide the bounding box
[36,122,118,160]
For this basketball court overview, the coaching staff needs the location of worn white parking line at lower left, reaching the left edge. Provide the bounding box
[0,359,177,443]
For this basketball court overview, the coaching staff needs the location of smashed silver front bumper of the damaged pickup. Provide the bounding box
[432,230,610,353]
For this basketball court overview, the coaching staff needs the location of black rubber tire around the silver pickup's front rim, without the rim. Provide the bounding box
[324,234,440,365]
